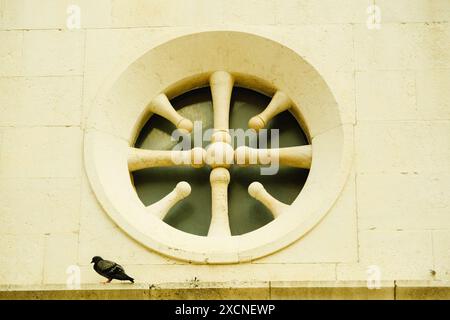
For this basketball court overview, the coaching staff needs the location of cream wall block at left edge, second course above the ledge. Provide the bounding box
[0,178,80,236]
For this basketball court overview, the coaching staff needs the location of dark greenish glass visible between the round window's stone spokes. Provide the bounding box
[133,88,309,235]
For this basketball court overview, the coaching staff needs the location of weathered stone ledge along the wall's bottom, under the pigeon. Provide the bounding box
[0,281,450,300]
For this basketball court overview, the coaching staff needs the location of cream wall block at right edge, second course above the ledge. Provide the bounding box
[357,173,450,231]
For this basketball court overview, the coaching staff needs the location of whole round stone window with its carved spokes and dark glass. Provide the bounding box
[85,32,353,263]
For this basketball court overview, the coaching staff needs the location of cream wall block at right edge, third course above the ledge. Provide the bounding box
[355,121,450,174]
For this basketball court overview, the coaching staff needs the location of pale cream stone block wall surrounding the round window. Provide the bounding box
[0,0,450,286]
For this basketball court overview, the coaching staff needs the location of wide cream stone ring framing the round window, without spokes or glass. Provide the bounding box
[84,31,353,264]
